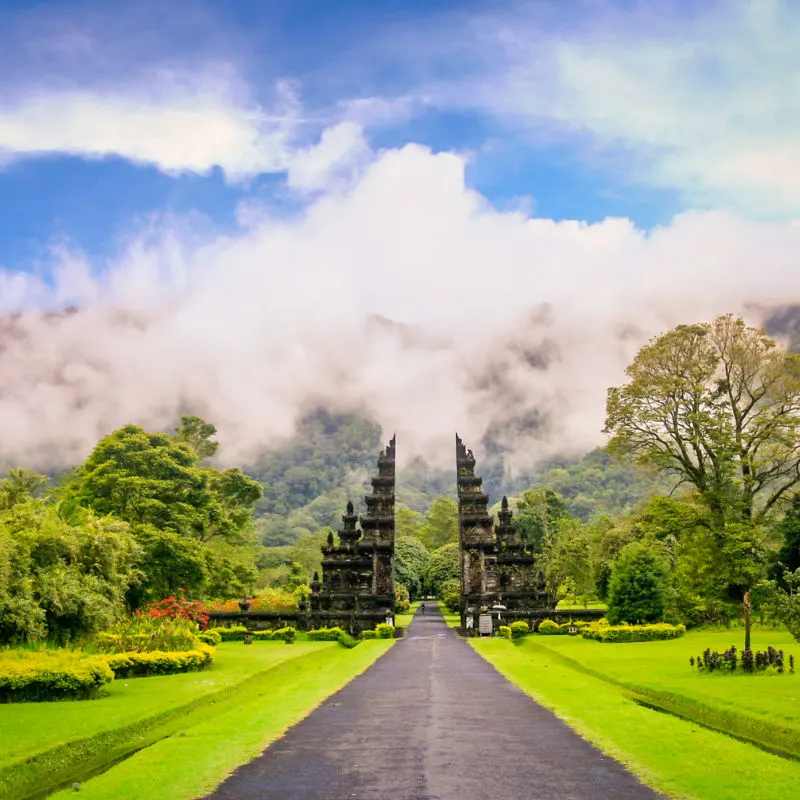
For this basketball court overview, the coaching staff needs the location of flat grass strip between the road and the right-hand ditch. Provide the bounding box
[471,634,800,800]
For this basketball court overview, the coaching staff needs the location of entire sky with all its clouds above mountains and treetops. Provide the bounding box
[0,0,800,464]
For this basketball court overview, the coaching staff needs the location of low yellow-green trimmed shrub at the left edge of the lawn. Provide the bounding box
[0,650,114,703]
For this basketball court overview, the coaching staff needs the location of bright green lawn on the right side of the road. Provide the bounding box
[470,631,800,800]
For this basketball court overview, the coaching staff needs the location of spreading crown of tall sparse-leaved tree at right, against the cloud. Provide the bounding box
[605,315,800,528]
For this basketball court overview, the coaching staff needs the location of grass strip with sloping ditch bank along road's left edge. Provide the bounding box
[0,641,392,800]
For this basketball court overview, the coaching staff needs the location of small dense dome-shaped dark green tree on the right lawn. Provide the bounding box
[606,542,669,624]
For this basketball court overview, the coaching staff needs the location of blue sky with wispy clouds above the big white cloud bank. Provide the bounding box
[0,0,800,271]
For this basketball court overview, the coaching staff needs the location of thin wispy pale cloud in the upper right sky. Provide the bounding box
[420,0,800,217]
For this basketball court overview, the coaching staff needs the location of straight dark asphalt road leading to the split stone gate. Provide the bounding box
[203,606,660,800]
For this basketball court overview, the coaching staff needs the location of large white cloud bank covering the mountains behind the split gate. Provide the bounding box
[0,145,800,463]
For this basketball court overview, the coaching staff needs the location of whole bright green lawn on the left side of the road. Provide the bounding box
[0,641,391,800]
